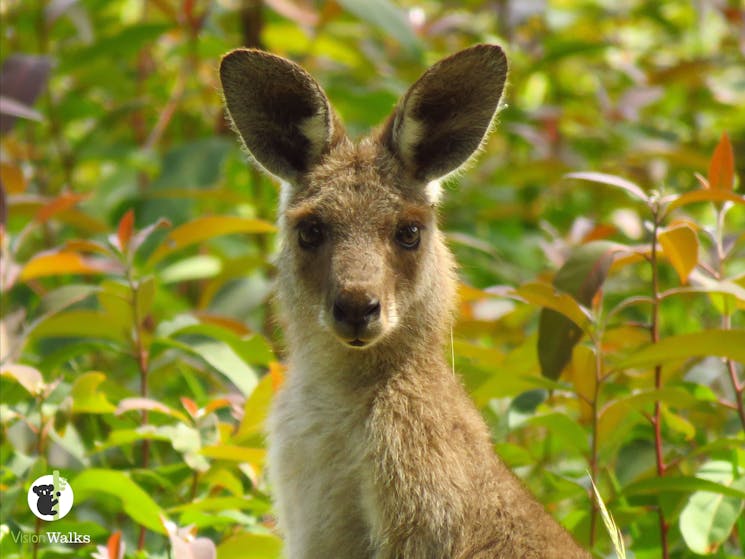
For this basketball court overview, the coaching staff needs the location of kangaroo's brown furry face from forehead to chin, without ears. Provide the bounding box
[280,142,437,348]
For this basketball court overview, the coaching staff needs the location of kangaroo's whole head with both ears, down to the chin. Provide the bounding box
[220,45,507,349]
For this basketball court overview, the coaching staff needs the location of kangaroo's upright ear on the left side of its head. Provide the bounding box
[220,49,334,182]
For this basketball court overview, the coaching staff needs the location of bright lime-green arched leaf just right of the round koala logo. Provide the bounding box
[70,469,166,534]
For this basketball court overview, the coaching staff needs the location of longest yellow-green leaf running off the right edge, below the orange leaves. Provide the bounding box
[614,330,745,370]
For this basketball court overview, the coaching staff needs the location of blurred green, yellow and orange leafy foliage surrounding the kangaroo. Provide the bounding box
[0,0,745,558]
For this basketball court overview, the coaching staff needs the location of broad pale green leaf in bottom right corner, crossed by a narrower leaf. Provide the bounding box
[680,461,745,555]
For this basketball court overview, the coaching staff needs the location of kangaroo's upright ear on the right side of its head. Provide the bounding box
[382,45,507,181]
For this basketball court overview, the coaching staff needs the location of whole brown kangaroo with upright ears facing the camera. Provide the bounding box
[220,45,589,559]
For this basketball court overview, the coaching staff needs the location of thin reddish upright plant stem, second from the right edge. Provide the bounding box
[650,213,670,559]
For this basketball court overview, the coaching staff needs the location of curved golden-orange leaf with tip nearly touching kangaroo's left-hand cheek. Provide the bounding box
[150,215,276,264]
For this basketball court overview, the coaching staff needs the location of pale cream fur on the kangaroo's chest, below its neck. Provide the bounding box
[268,358,370,559]
